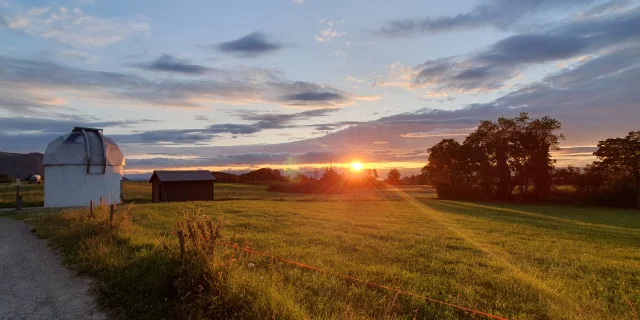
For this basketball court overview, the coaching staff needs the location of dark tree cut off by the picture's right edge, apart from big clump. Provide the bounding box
[593,131,640,209]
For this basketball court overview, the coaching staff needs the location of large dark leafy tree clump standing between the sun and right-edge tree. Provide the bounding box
[422,112,563,200]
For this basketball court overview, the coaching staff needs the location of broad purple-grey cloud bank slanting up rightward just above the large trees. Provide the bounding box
[330,44,640,165]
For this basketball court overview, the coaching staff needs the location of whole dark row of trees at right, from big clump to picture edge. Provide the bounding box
[421,113,640,207]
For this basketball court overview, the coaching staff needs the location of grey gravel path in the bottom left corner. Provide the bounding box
[0,218,107,320]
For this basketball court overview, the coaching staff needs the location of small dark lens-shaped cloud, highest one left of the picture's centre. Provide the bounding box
[216,31,284,58]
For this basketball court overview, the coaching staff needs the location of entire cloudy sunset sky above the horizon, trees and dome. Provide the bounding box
[0,0,640,174]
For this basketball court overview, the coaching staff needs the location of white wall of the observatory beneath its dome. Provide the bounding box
[44,165,123,208]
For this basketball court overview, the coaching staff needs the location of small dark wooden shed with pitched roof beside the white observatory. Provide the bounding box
[149,170,216,202]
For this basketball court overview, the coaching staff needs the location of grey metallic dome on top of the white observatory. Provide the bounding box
[42,127,125,168]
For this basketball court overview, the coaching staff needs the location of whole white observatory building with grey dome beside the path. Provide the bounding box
[42,127,124,208]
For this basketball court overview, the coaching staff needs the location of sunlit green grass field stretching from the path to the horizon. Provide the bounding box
[0,183,640,319]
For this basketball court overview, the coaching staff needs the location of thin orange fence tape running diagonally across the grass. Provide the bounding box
[222,243,509,320]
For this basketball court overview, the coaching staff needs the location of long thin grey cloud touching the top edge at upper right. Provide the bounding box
[374,0,599,37]
